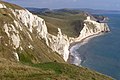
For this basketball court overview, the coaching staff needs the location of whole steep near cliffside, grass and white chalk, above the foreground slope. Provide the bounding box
[0,1,66,62]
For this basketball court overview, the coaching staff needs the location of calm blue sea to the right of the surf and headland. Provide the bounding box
[78,14,120,80]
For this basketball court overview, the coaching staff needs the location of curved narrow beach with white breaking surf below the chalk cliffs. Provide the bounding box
[68,32,107,66]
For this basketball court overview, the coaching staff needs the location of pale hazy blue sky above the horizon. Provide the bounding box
[4,0,120,10]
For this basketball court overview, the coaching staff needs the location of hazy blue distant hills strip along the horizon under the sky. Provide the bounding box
[27,8,120,14]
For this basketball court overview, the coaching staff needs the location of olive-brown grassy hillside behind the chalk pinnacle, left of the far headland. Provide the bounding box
[32,9,87,37]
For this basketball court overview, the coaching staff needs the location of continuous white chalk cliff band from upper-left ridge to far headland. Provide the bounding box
[9,10,109,61]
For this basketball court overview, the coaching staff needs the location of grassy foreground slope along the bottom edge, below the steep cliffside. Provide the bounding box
[0,59,112,80]
